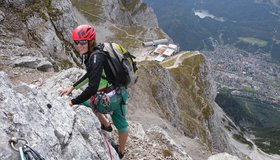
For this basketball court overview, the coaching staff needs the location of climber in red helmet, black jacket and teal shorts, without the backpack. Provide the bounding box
[59,24,128,158]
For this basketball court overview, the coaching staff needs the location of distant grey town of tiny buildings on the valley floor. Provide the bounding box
[202,46,280,103]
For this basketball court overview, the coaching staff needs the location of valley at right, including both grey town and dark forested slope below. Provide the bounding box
[203,46,280,154]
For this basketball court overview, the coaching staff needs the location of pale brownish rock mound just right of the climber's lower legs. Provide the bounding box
[125,121,192,160]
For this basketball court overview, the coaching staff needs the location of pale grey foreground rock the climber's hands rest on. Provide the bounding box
[0,69,118,160]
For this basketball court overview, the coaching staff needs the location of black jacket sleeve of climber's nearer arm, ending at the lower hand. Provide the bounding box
[71,53,105,105]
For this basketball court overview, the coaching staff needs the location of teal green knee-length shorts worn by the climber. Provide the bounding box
[82,88,128,133]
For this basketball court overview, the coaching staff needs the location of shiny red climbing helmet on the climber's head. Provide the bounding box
[72,24,96,41]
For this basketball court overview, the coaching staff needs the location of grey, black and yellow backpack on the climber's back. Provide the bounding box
[100,43,138,88]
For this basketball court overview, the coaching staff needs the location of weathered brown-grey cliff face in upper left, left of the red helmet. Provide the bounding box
[0,0,77,70]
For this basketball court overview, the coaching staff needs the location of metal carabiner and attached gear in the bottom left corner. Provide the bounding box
[9,137,45,160]
